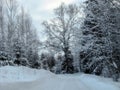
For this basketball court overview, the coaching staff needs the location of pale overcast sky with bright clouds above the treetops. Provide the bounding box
[18,0,84,40]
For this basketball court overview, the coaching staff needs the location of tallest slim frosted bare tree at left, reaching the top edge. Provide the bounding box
[6,0,18,55]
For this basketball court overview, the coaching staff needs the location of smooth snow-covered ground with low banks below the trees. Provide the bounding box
[0,66,120,90]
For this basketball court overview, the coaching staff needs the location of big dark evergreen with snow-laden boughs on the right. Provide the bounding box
[80,0,119,80]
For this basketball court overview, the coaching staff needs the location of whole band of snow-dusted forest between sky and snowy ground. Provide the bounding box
[0,0,120,81]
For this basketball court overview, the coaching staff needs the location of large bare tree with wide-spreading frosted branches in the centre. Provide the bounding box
[43,4,80,73]
